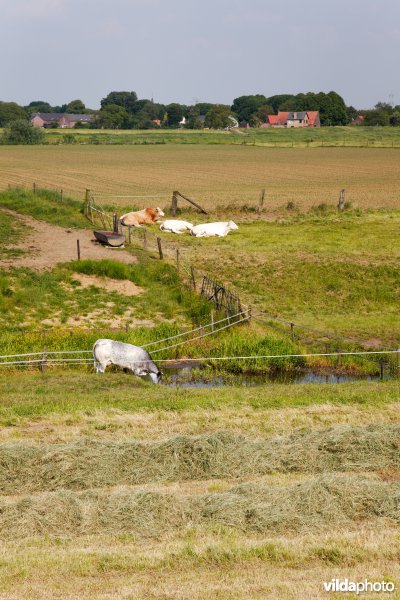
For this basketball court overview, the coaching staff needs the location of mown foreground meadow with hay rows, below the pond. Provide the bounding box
[0,372,400,600]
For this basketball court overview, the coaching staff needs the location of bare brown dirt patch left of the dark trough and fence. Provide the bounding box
[0,209,136,271]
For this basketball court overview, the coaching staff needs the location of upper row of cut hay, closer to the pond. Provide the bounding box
[0,424,400,494]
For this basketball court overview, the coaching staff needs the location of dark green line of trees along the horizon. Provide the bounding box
[0,91,400,129]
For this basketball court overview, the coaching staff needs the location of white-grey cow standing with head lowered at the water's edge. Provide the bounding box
[93,340,162,383]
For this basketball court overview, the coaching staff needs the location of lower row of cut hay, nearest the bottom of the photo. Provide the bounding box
[0,475,400,539]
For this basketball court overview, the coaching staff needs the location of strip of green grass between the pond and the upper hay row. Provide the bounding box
[0,370,400,426]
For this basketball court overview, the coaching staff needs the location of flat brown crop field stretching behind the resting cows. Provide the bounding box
[0,144,400,209]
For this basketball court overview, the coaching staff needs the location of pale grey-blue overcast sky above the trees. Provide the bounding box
[0,0,400,108]
